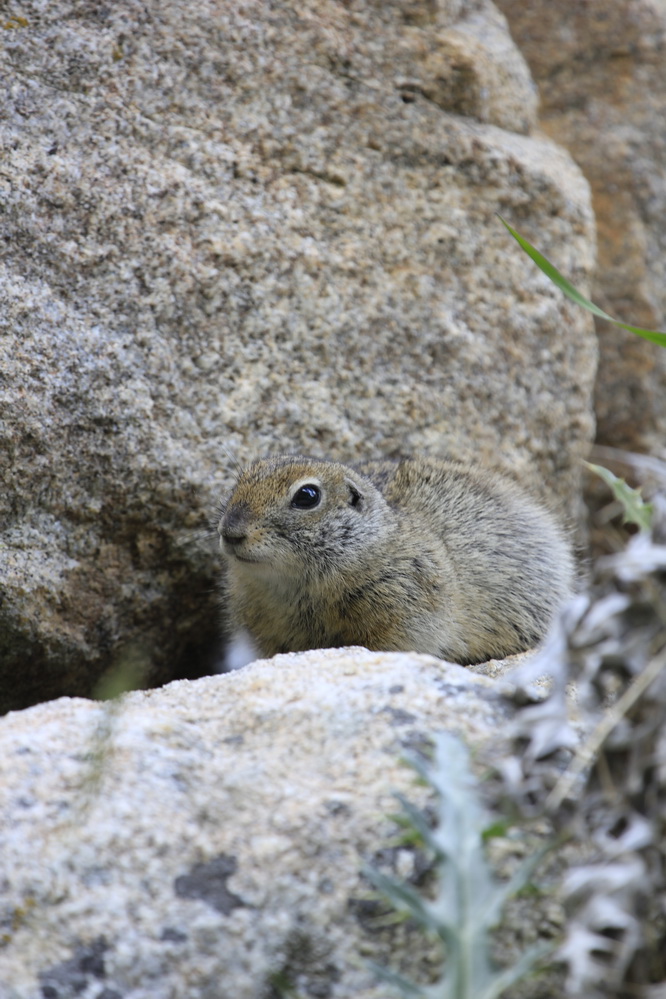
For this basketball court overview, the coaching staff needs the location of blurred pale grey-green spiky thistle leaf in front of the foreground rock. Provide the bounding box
[366,733,551,999]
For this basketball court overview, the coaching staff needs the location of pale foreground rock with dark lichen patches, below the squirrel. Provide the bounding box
[0,650,556,999]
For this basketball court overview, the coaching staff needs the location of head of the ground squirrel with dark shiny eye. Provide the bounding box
[218,455,392,575]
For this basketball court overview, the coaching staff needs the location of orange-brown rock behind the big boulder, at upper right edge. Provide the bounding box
[498,0,666,456]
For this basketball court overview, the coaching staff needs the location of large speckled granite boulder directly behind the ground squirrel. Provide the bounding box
[0,0,596,710]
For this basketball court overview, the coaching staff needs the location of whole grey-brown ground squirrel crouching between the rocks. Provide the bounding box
[218,455,573,668]
